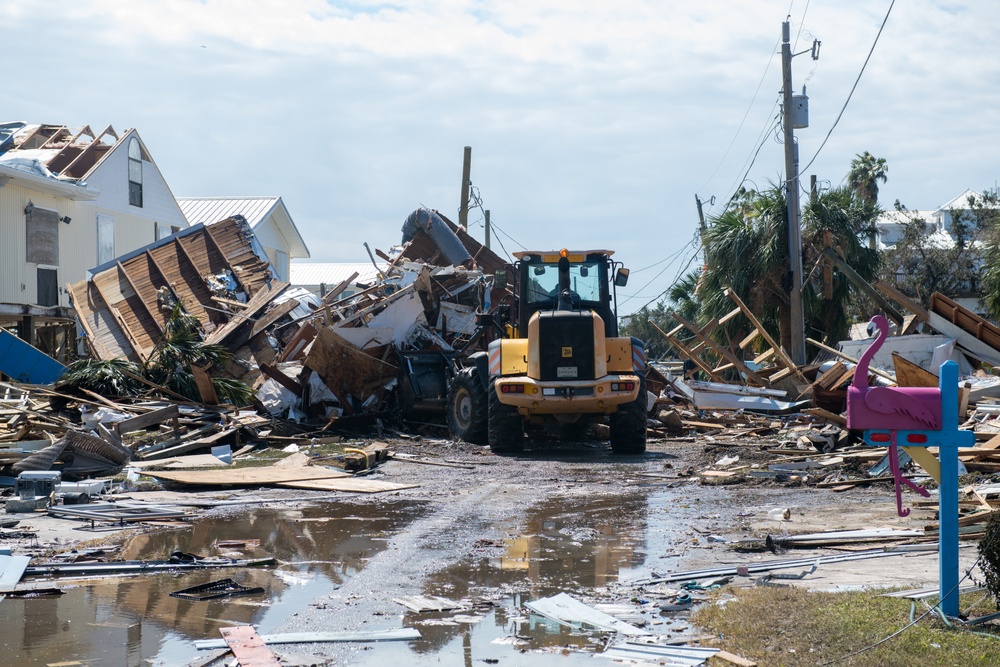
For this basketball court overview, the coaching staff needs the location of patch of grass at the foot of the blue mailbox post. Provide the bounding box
[692,586,1000,667]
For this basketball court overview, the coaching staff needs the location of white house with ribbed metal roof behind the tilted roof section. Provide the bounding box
[177,197,310,281]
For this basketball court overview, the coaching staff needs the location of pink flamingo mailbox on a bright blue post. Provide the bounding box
[847,315,976,616]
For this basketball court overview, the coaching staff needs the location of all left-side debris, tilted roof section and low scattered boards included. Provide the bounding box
[0,209,507,488]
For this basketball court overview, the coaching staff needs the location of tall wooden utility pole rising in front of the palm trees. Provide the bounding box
[781,21,806,365]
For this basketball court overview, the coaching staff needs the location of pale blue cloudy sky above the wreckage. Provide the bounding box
[0,0,1000,315]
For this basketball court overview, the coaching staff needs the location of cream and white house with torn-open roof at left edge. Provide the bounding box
[0,121,188,353]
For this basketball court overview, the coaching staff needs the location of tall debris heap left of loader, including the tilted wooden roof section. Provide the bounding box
[58,209,506,428]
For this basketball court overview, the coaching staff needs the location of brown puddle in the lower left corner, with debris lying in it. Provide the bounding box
[0,503,420,667]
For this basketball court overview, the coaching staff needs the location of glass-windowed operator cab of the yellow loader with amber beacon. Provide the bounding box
[514,250,627,338]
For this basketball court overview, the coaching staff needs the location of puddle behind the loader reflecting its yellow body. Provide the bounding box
[350,496,669,667]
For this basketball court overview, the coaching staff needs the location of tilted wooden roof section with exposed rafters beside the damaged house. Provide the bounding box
[69,217,280,362]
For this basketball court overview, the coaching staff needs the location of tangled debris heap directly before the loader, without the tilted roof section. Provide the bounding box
[247,209,506,421]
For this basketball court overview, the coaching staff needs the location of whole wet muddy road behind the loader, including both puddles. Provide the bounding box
[0,439,952,667]
